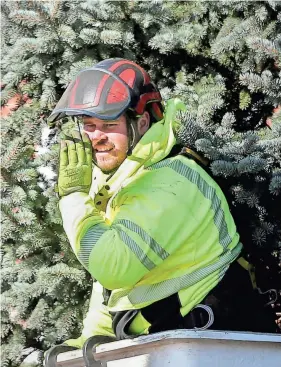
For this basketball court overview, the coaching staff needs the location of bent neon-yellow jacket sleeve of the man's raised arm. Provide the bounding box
[57,170,194,290]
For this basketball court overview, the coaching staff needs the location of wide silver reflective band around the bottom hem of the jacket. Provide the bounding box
[109,243,242,307]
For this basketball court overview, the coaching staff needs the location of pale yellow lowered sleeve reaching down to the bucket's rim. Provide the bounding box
[64,282,115,348]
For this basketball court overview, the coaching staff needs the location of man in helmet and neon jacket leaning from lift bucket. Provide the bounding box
[47,59,272,347]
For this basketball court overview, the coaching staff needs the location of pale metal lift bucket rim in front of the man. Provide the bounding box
[45,330,281,367]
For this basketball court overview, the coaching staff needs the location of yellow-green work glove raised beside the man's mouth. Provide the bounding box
[58,130,92,197]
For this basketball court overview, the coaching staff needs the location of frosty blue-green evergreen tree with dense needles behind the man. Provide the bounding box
[1,0,281,366]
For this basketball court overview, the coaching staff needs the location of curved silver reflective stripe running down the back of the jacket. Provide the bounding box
[148,158,232,249]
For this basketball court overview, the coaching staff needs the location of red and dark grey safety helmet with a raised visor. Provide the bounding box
[49,58,163,122]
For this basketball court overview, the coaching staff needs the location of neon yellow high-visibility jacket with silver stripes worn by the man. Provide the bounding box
[60,99,242,347]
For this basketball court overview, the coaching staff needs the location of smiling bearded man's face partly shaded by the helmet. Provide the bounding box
[83,115,129,173]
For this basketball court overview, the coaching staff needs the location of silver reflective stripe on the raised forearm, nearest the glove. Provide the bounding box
[77,224,108,269]
